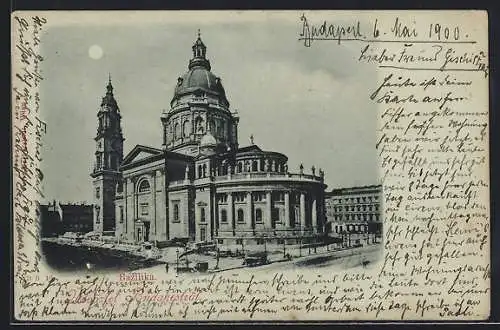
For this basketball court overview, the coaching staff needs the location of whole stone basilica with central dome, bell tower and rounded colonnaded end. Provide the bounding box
[91,35,326,249]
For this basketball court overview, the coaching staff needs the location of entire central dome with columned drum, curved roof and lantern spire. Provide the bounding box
[161,34,239,156]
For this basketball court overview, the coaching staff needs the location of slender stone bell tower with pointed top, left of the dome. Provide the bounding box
[90,76,125,232]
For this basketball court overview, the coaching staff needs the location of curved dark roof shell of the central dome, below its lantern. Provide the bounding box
[174,66,226,99]
